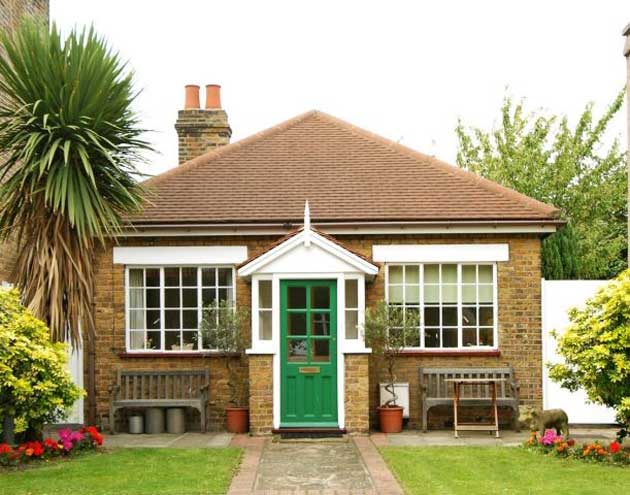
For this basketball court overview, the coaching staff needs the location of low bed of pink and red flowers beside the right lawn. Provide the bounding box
[525,430,630,465]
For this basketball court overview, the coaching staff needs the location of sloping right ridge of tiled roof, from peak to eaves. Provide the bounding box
[312,110,559,216]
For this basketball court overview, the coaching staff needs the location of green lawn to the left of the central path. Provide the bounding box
[0,448,241,495]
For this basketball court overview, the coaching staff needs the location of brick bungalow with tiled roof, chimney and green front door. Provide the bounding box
[96,86,561,434]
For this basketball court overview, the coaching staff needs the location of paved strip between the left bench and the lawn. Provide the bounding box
[104,432,233,449]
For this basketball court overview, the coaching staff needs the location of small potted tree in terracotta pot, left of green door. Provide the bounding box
[200,301,249,433]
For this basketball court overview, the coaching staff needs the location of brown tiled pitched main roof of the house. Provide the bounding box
[132,111,558,225]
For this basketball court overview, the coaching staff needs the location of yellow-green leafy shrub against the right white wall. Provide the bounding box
[549,270,630,442]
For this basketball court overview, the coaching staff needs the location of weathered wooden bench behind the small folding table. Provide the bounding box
[419,367,519,432]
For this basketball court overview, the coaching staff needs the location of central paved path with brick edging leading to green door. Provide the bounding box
[228,436,403,495]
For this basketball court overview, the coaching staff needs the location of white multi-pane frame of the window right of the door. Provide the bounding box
[384,261,499,353]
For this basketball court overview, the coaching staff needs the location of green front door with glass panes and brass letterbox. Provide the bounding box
[280,280,337,427]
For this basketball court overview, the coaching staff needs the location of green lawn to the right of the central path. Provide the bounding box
[381,447,630,495]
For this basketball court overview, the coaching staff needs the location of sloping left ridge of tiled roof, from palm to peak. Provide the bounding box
[143,110,319,186]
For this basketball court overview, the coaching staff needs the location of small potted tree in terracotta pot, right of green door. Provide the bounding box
[364,301,419,433]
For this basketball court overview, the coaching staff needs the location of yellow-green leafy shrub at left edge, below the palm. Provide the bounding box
[0,289,82,443]
